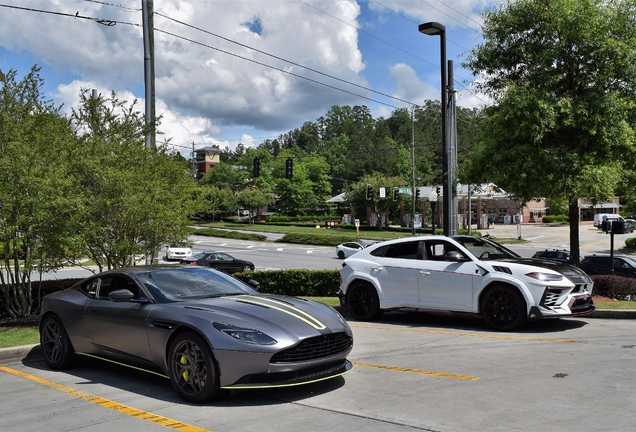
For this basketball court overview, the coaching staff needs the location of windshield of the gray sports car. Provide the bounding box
[138,267,258,303]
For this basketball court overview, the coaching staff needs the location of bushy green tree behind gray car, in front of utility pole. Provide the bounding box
[71,90,195,271]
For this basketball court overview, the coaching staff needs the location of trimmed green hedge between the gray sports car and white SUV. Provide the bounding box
[234,270,340,297]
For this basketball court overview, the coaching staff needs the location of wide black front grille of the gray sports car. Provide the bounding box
[270,333,353,363]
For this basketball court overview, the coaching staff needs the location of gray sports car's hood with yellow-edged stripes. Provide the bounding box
[173,294,352,338]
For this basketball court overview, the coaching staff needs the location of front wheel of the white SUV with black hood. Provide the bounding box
[481,285,527,331]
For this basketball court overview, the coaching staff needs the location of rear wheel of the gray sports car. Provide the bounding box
[40,315,75,370]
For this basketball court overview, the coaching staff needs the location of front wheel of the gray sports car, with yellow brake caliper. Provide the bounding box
[168,332,221,403]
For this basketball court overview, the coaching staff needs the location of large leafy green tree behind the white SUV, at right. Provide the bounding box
[462,0,636,262]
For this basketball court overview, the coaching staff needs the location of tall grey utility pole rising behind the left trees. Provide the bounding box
[141,0,157,150]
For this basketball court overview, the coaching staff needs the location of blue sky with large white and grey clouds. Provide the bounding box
[0,0,501,158]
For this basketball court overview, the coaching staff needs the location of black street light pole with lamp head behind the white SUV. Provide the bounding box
[418,22,453,236]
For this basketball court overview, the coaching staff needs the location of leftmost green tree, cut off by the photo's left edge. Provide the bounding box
[0,66,75,318]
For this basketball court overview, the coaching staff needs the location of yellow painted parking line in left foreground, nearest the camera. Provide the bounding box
[0,366,211,432]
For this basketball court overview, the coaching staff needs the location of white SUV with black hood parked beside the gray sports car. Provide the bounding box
[338,236,596,331]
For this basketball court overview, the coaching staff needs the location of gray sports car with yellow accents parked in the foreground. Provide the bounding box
[40,266,353,403]
